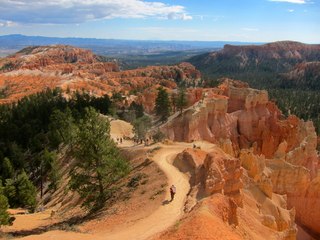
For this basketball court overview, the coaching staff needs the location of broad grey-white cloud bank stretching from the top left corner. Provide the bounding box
[0,0,192,24]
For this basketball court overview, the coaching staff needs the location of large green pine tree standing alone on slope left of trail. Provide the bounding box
[70,108,129,210]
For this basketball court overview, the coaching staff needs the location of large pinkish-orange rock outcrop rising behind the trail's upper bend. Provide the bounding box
[163,80,303,157]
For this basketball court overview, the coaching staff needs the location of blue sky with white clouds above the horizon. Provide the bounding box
[0,0,320,43]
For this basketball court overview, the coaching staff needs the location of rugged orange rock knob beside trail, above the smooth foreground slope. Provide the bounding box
[173,147,243,212]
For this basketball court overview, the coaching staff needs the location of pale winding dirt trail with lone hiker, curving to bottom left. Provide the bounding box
[16,142,213,240]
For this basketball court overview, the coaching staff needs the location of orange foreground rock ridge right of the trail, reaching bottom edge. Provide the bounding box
[166,145,297,240]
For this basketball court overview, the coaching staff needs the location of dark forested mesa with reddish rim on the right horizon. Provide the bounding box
[189,41,320,88]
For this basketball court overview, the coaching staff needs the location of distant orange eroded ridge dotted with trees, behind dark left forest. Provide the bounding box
[0,45,201,104]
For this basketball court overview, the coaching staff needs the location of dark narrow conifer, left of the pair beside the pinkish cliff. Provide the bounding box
[155,87,170,122]
